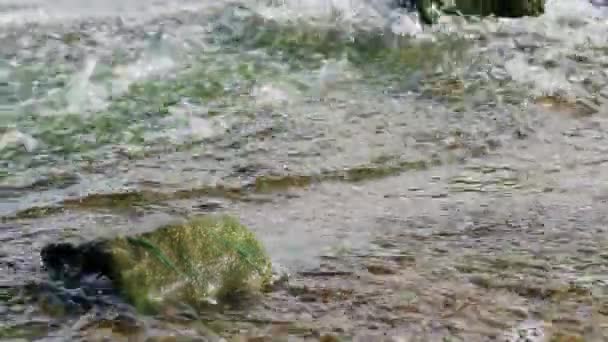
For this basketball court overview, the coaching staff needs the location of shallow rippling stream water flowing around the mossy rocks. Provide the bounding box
[0,0,608,341]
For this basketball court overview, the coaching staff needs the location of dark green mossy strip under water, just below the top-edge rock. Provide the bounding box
[218,14,470,77]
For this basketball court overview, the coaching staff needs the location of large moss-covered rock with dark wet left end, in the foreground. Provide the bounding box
[41,216,271,311]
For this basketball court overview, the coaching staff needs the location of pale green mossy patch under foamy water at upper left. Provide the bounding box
[5,52,276,174]
